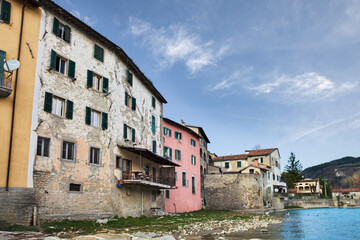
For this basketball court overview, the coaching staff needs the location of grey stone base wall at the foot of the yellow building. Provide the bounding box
[0,187,35,225]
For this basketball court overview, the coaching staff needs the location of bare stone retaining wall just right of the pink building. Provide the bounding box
[205,174,264,210]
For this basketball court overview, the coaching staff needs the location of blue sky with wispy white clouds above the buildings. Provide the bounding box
[55,0,360,169]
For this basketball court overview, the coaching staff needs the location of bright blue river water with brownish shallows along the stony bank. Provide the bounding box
[202,208,360,240]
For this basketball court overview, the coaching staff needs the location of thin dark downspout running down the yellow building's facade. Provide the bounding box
[6,0,28,191]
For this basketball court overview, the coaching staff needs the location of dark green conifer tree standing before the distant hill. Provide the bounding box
[281,152,302,188]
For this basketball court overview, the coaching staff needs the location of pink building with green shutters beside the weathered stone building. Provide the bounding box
[164,118,201,213]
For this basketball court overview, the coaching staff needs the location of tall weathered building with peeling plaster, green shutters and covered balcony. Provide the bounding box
[33,0,177,221]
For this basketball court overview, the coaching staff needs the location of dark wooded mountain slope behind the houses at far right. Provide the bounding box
[302,157,360,188]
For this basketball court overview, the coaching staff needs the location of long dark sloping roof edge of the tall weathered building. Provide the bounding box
[38,0,167,103]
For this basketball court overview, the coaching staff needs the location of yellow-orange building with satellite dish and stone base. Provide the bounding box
[0,0,41,224]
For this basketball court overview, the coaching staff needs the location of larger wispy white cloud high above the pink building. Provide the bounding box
[129,17,228,73]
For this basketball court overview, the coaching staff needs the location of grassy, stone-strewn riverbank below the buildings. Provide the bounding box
[0,210,282,240]
